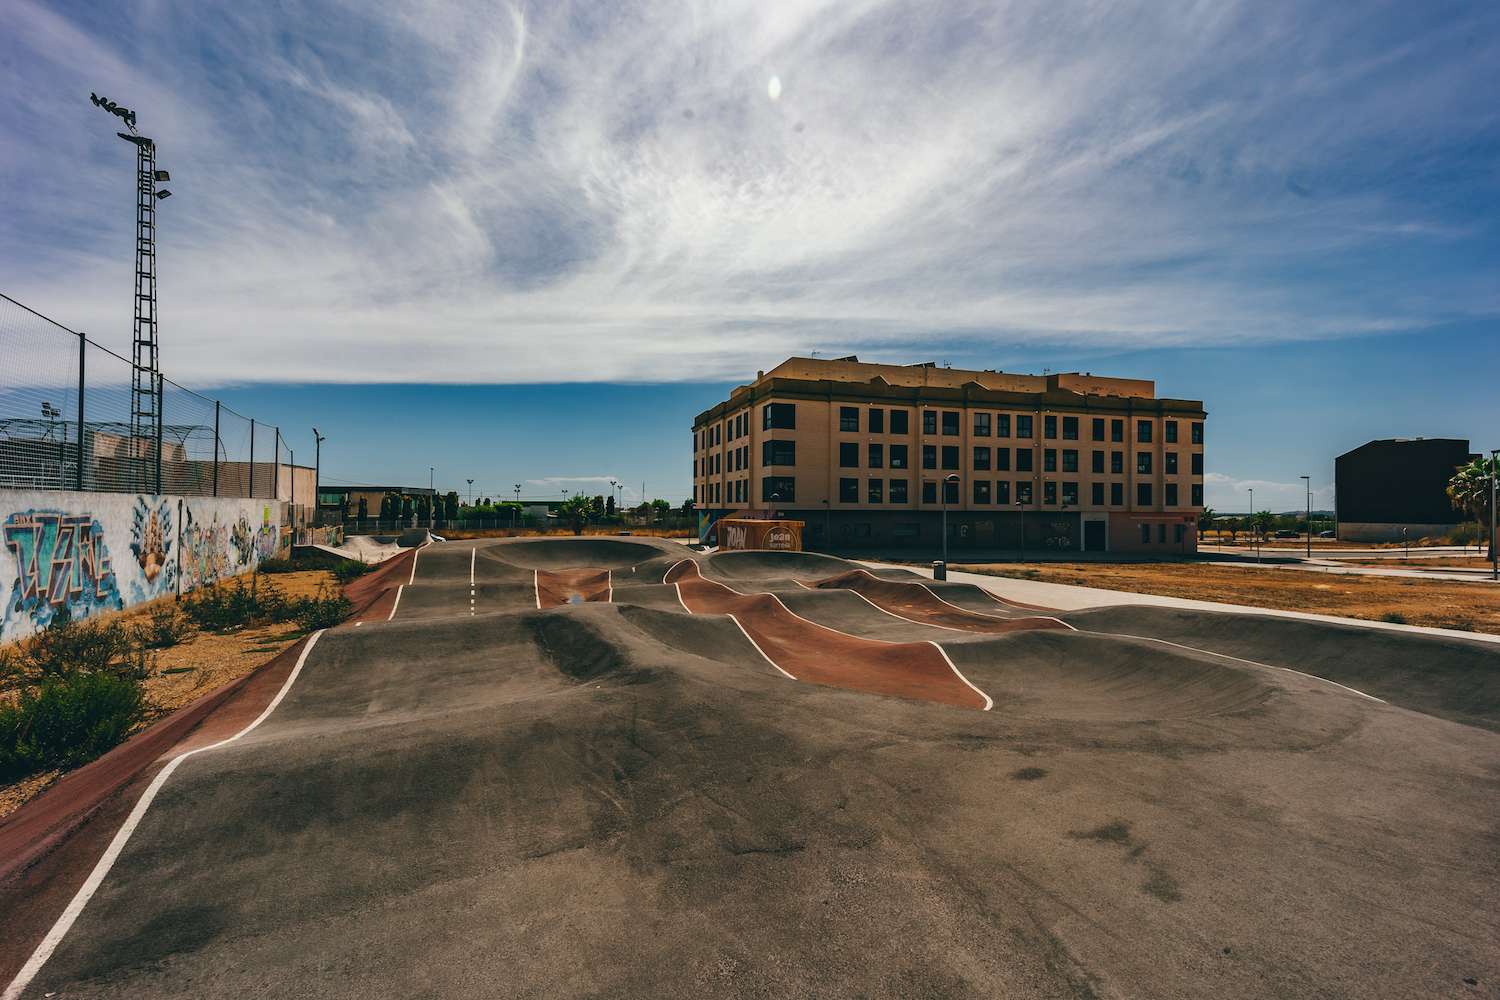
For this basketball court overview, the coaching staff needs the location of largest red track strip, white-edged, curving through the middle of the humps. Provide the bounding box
[663,559,993,709]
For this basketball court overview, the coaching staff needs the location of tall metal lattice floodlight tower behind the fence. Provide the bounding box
[89,94,173,493]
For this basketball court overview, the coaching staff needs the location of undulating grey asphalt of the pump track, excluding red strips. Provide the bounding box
[26,538,1500,999]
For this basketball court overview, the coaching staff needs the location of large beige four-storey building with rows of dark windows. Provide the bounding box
[693,357,1206,555]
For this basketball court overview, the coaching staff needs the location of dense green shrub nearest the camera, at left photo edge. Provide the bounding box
[0,672,152,781]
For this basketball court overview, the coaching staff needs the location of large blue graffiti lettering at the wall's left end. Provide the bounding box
[0,510,123,636]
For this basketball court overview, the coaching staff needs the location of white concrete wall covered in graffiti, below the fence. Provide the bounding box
[0,490,284,643]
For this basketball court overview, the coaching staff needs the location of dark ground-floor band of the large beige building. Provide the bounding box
[699,507,1199,555]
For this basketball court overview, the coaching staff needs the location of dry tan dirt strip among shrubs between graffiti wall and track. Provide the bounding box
[0,570,339,817]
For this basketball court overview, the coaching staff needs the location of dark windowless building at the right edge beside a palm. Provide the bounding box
[1334,438,1479,541]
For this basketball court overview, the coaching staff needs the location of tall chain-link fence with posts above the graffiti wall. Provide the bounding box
[0,294,290,498]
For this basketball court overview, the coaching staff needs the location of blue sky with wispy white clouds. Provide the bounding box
[0,0,1500,510]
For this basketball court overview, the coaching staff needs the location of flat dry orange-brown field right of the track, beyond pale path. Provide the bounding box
[953,562,1500,634]
